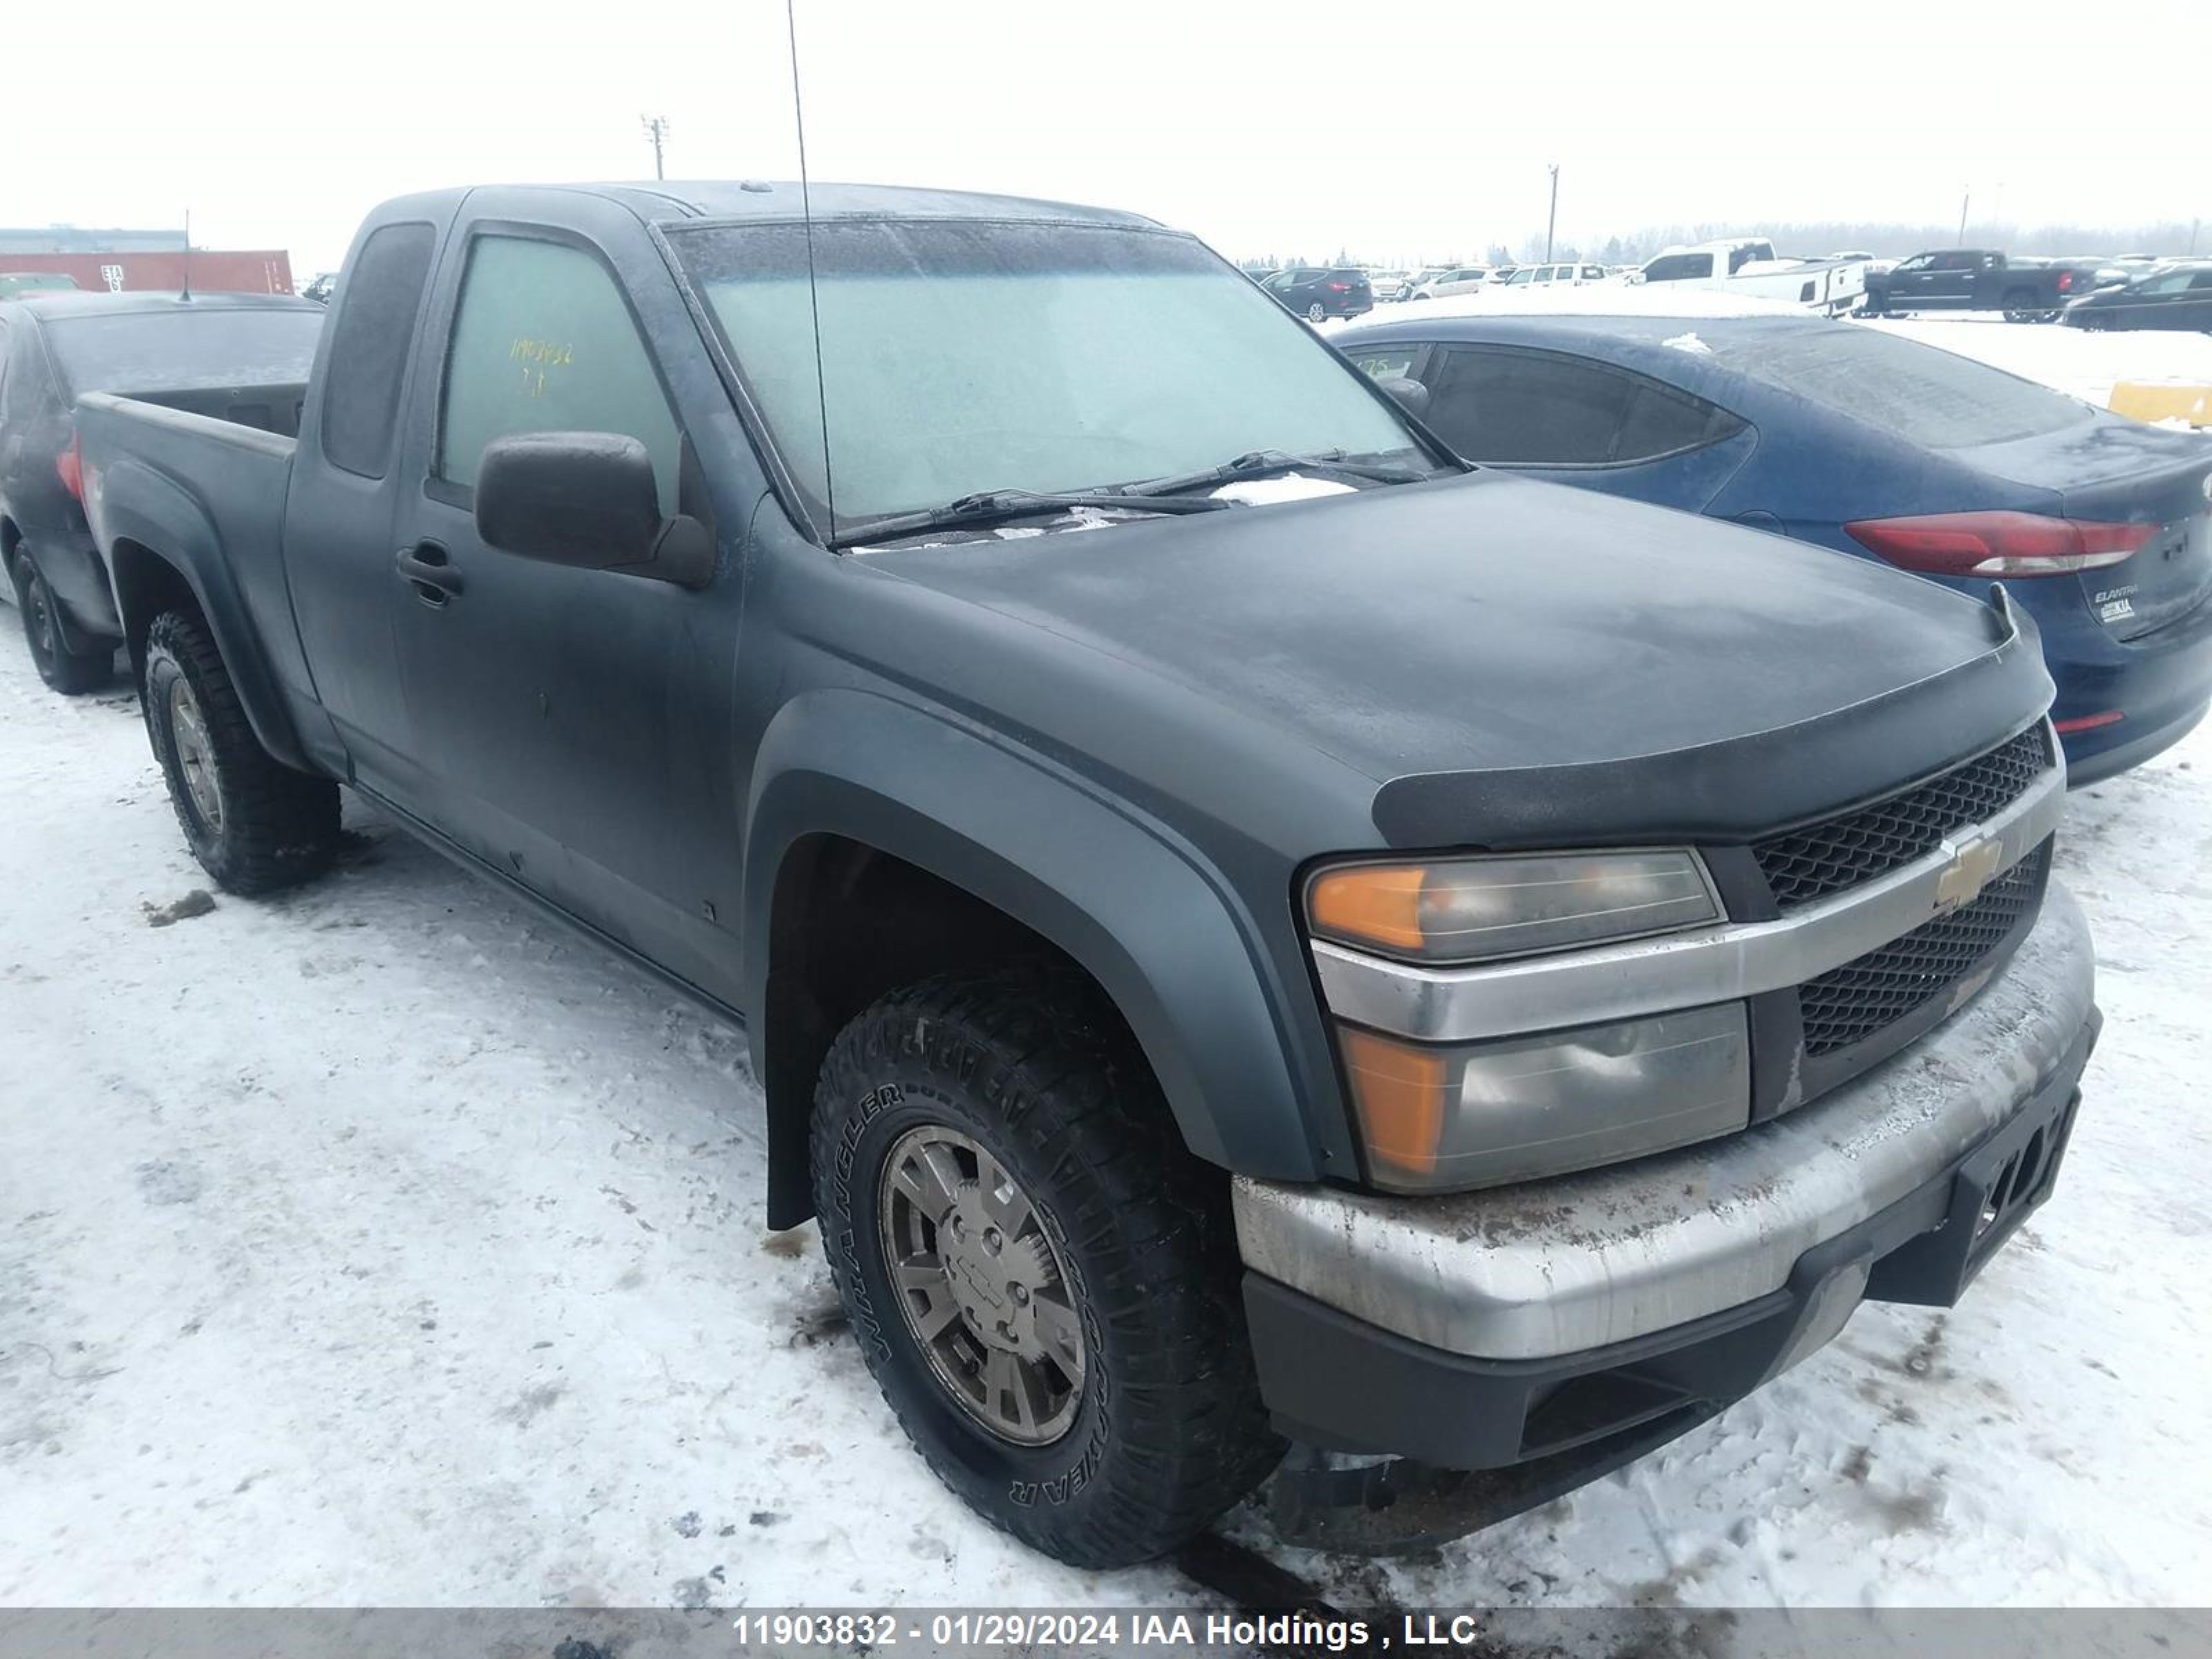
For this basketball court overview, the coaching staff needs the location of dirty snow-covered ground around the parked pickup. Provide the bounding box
[0,323,2212,1606]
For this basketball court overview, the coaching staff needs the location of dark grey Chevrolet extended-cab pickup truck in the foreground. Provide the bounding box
[77,184,2097,1564]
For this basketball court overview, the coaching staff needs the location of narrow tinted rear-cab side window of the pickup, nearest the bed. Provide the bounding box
[323,223,435,478]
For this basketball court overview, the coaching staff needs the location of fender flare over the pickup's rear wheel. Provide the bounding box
[97,456,314,772]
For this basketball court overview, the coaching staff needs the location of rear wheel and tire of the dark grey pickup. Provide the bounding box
[142,610,339,896]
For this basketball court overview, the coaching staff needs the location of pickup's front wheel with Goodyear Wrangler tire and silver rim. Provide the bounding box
[814,971,1283,1566]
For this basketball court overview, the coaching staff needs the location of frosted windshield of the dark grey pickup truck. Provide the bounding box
[671,219,1427,529]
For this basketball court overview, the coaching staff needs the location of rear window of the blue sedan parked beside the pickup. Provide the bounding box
[1712,323,2090,449]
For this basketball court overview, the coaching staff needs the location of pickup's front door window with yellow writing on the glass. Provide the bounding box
[435,236,682,513]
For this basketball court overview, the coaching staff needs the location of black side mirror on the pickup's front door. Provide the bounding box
[476,431,715,588]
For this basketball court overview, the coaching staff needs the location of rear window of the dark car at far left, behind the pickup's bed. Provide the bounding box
[46,306,323,396]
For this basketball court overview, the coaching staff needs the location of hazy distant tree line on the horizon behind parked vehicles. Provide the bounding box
[1239,219,2212,270]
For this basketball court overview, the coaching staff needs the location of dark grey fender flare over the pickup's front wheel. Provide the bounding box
[743,690,1316,1212]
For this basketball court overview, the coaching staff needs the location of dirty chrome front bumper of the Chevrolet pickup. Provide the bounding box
[1235,883,2094,1360]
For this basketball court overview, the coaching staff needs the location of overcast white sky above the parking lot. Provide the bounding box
[0,0,2212,279]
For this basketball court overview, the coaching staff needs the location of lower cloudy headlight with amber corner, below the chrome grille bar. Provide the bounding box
[1336,1002,1752,1192]
